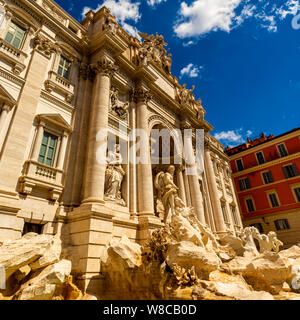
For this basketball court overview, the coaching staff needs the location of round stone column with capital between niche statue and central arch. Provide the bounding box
[136,88,154,215]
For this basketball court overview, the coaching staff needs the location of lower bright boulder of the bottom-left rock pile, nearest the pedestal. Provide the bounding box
[15,260,71,300]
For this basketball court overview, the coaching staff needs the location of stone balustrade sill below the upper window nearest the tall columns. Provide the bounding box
[45,71,75,103]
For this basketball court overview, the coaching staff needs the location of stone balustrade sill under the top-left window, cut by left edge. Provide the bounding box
[0,39,27,75]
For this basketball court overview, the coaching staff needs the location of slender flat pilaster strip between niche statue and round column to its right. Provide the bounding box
[129,92,137,214]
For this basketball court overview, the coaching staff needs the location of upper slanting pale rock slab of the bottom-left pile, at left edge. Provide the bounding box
[0,233,61,279]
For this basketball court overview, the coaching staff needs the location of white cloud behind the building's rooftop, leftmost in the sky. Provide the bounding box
[82,0,142,37]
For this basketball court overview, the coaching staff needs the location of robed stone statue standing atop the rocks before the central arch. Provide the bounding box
[154,166,185,223]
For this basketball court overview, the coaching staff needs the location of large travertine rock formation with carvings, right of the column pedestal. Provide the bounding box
[103,208,300,300]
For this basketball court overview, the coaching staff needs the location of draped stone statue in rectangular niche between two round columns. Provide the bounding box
[104,144,126,206]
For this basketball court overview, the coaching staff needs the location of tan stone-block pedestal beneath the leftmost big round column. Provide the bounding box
[64,203,163,299]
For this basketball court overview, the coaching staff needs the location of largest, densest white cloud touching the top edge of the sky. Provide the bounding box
[174,0,242,38]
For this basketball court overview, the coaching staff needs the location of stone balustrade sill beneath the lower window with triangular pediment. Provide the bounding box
[19,160,63,201]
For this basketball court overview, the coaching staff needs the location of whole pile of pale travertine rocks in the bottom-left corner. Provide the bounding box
[0,233,95,300]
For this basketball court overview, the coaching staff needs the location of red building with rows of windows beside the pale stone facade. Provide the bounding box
[225,128,300,247]
